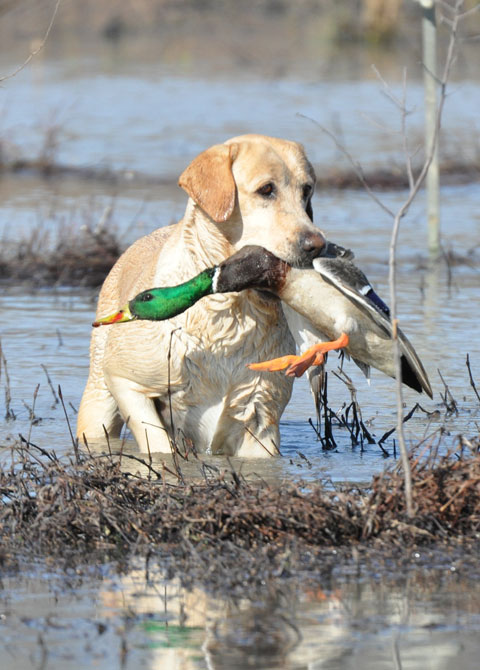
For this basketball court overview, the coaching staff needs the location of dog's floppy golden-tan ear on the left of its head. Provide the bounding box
[178,144,237,223]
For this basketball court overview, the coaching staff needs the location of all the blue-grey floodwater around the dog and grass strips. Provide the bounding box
[0,2,480,670]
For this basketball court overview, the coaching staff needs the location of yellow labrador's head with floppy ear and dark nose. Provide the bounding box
[179,135,325,266]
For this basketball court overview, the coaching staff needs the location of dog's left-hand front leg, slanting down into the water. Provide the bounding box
[107,377,171,454]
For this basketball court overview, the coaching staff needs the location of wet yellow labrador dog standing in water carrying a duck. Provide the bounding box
[77,135,325,457]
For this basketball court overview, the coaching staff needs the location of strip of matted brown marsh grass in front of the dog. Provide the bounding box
[0,428,480,570]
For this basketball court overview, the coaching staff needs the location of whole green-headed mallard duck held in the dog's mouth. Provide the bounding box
[93,245,432,397]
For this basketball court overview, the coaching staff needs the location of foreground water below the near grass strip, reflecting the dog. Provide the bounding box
[0,553,480,670]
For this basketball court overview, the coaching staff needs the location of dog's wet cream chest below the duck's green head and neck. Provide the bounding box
[105,291,294,396]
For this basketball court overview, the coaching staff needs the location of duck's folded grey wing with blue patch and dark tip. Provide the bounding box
[313,258,432,398]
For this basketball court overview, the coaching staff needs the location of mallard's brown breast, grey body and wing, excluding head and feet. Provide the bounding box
[216,245,432,397]
